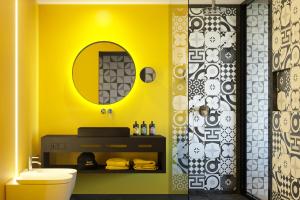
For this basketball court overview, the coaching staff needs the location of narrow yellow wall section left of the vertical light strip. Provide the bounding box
[0,0,14,200]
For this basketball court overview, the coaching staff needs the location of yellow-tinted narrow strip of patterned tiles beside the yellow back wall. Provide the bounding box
[171,4,188,193]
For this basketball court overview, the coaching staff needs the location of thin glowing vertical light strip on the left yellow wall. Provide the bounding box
[14,0,19,177]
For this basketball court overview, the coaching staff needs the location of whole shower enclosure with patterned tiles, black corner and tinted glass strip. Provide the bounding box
[171,0,272,200]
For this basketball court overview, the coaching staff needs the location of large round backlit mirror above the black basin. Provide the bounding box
[73,42,136,104]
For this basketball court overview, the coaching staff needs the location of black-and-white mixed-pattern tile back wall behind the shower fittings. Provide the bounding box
[188,5,237,191]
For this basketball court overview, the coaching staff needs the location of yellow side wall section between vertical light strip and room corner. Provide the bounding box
[19,0,38,171]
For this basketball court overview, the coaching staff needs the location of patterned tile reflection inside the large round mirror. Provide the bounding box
[99,52,135,104]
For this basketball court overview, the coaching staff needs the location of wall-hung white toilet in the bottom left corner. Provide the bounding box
[6,169,77,200]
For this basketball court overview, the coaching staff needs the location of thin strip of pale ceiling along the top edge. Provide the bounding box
[37,0,244,4]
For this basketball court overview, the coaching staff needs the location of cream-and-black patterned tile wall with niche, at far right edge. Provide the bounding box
[272,0,300,200]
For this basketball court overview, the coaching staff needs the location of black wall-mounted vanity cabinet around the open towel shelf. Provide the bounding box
[41,135,166,173]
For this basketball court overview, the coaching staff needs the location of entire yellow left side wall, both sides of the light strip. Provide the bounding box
[0,0,38,200]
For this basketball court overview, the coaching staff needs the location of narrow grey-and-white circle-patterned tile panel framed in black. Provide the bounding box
[247,0,270,200]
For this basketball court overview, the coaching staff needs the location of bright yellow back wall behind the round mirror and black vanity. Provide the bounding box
[39,5,171,194]
